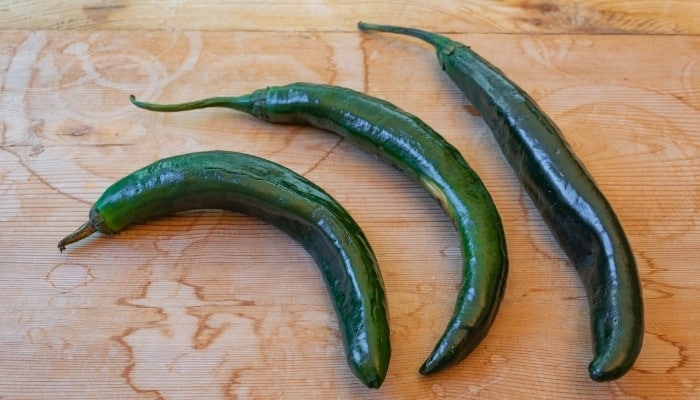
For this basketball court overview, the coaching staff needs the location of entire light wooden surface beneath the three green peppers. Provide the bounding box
[0,0,700,399]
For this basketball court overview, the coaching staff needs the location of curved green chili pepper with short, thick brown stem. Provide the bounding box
[58,151,391,388]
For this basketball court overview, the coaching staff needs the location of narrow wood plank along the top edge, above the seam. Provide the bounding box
[0,0,700,35]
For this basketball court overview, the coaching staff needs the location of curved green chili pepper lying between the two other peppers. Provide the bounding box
[132,83,508,378]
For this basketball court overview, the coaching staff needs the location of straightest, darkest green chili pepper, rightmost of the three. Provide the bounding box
[359,23,644,381]
